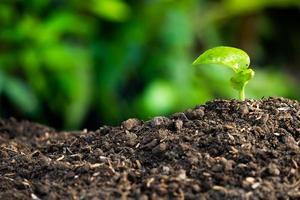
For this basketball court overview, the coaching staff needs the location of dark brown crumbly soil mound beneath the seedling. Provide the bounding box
[0,98,300,200]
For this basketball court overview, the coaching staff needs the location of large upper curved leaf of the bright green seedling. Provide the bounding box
[193,46,250,72]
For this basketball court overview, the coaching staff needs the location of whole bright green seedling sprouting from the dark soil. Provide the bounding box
[193,46,254,101]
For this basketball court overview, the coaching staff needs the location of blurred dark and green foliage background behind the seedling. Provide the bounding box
[0,0,300,129]
